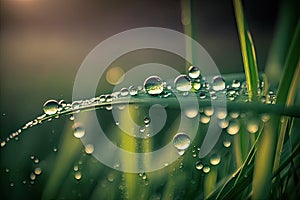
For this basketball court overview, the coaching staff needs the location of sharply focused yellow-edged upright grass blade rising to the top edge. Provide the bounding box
[233,0,259,101]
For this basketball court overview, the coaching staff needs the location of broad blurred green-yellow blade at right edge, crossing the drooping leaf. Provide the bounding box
[252,19,300,199]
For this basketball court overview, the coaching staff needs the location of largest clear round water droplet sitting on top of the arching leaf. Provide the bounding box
[144,76,164,95]
